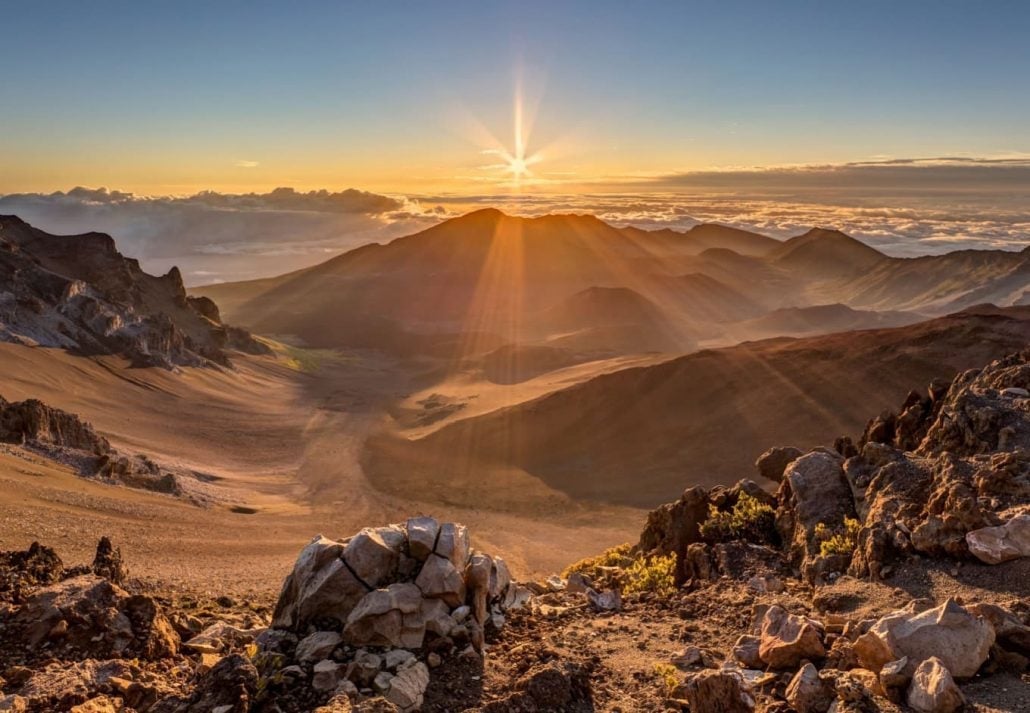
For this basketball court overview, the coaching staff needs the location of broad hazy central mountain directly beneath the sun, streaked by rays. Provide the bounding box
[195,209,753,356]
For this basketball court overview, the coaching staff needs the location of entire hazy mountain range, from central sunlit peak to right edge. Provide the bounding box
[194,209,1030,358]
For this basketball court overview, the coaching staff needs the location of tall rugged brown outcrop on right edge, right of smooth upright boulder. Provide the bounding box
[845,352,1030,577]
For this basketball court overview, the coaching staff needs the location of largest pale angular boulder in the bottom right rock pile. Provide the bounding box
[855,599,995,678]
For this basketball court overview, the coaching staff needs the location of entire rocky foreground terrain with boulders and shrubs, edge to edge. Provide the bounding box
[0,352,1030,713]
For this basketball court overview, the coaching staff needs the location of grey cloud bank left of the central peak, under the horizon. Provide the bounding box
[0,188,440,284]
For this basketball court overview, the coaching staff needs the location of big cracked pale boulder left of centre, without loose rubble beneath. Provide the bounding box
[272,517,519,649]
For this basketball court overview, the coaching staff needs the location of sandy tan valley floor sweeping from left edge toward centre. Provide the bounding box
[0,344,645,600]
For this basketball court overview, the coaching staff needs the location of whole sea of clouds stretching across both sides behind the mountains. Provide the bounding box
[0,169,1030,285]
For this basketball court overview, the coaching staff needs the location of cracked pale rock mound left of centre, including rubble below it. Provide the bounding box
[253,517,527,711]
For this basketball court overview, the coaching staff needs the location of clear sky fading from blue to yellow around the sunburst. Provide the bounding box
[0,1,1030,194]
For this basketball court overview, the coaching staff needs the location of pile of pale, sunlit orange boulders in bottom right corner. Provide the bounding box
[684,600,1030,713]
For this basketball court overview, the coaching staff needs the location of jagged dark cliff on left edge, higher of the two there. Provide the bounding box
[0,215,267,367]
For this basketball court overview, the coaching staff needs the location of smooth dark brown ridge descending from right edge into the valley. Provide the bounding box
[365,308,1030,505]
